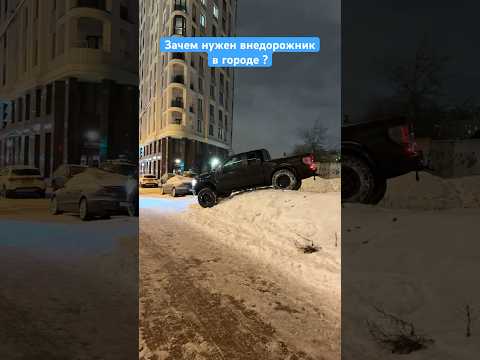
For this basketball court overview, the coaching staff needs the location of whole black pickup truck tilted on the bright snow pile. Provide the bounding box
[193,149,317,208]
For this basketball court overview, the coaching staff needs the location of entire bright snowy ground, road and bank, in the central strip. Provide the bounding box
[140,190,341,360]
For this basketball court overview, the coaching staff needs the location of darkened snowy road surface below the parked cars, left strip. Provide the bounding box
[0,199,138,360]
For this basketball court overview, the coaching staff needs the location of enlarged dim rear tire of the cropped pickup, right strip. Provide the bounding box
[342,155,375,204]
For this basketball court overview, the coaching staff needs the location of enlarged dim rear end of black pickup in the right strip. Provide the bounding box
[342,118,423,204]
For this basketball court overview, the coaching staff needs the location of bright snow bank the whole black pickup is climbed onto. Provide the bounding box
[179,189,341,300]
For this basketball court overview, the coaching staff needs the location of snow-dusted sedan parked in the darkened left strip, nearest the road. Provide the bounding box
[50,165,130,221]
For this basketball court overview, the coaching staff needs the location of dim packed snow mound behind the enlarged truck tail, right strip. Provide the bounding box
[379,172,480,210]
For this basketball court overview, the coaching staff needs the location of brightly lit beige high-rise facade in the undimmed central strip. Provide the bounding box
[139,0,236,176]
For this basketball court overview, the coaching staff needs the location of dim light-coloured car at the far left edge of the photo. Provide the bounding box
[0,166,46,197]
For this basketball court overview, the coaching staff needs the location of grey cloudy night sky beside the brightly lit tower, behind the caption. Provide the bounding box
[233,0,341,156]
